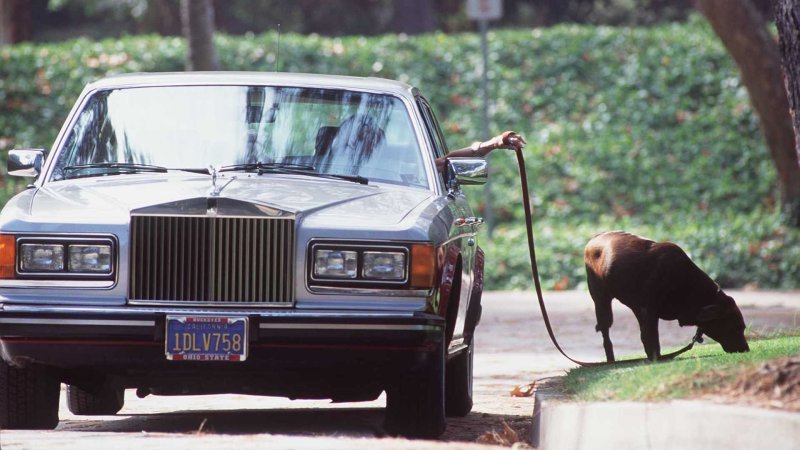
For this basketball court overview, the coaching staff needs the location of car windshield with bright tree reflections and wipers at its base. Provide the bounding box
[51,86,428,188]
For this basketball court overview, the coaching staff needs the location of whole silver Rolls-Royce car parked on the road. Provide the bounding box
[0,72,486,437]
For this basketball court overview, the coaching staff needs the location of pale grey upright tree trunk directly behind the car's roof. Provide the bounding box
[181,0,219,71]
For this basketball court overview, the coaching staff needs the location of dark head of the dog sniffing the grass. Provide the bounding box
[697,290,750,353]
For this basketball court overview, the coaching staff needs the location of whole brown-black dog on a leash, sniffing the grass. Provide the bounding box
[583,231,750,361]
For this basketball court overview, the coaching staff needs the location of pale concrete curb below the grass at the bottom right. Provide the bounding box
[531,387,800,450]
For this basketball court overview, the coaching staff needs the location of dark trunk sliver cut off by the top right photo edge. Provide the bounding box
[774,0,800,165]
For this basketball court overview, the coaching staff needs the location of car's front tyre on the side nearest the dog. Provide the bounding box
[386,343,446,439]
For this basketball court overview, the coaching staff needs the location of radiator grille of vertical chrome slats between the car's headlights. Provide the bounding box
[129,216,295,305]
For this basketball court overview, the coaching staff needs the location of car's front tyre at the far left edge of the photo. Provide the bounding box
[0,360,61,430]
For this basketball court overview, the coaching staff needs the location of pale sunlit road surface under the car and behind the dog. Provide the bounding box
[0,291,800,450]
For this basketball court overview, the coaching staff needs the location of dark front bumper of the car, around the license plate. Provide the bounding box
[0,304,444,372]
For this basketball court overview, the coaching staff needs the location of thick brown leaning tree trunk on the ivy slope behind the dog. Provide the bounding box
[695,0,800,227]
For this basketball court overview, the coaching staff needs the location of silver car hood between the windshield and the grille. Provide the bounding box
[28,174,432,224]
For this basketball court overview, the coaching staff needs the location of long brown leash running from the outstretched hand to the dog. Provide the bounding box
[514,147,703,367]
